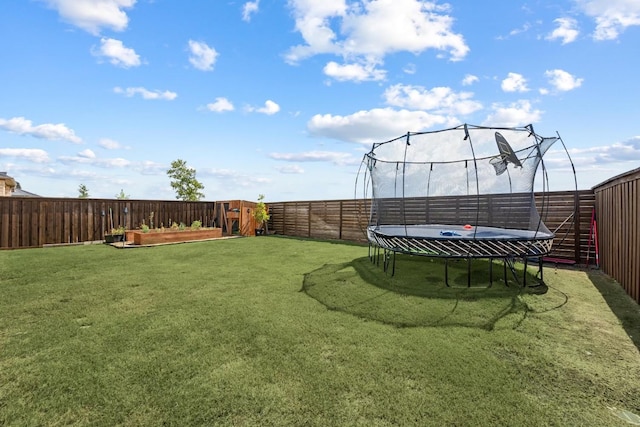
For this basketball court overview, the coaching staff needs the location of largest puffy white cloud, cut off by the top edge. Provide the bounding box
[286,0,469,63]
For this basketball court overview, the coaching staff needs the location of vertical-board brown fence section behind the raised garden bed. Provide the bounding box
[0,197,220,248]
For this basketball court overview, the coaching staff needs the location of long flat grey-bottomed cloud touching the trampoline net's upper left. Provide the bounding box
[307,108,456,143]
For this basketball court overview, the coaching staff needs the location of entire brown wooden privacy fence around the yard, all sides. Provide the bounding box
[0,189,640,303]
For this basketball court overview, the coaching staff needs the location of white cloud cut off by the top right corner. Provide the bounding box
[575,0,640,40]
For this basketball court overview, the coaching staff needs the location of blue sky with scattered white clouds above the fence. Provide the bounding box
[0,0,640,201]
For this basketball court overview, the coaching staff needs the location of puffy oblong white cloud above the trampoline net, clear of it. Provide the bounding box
[383,84,482,115]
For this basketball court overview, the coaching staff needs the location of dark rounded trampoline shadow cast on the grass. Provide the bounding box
[302,256,547,330]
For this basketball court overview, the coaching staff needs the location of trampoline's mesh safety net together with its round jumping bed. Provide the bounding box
[363,124,559,260]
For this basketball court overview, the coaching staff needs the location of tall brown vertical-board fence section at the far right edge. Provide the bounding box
[594,168,640,304]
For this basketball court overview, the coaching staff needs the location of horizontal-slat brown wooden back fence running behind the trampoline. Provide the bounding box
[269,190,595,263]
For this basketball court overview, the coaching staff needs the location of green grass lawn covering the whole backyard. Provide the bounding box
[0,236,640,426]
